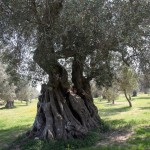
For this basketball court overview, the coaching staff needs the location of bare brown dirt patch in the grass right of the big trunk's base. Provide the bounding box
[96,130,134,147]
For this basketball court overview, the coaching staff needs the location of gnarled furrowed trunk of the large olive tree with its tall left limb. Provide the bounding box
[27,0,100,140]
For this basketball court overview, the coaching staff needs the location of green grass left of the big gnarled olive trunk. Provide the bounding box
[0,100,37,149]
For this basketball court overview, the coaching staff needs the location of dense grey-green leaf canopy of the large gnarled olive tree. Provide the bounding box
[1,0,150,84]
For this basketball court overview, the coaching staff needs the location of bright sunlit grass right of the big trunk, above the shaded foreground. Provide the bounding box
[95,94,150,127]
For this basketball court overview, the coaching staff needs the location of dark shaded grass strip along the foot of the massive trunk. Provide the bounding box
[3,127,100,150]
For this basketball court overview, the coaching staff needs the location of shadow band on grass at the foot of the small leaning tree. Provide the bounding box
[98,107,132,116]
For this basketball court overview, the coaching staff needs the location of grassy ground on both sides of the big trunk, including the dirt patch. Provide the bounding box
[0,94,150,150]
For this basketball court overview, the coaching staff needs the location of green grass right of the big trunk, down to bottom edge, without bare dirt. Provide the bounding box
[82,94,150,150]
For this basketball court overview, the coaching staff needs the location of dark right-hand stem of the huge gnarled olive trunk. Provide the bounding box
[72,56,100,125]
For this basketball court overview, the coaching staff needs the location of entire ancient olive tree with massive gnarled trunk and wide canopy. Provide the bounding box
[0,0,149,139]
